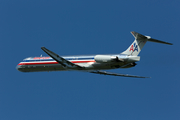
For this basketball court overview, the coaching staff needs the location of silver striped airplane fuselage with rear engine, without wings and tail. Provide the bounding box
[17,54,139,72]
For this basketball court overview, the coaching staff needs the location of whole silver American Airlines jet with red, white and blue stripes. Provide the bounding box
[16,31,172,78]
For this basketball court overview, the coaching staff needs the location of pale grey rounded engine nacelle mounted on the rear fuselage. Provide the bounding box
[94,55,117,63]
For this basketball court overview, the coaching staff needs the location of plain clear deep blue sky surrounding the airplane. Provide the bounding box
[0,0,180,120]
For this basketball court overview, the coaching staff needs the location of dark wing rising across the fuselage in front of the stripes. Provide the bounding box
[41,47,83,69]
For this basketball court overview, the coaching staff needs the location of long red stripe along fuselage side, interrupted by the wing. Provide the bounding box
[18,60,95,65]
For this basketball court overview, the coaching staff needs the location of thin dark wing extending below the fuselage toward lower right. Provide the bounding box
[90,70,150,78]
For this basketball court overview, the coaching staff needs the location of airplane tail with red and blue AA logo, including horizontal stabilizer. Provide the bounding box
[121,31,172,56]
